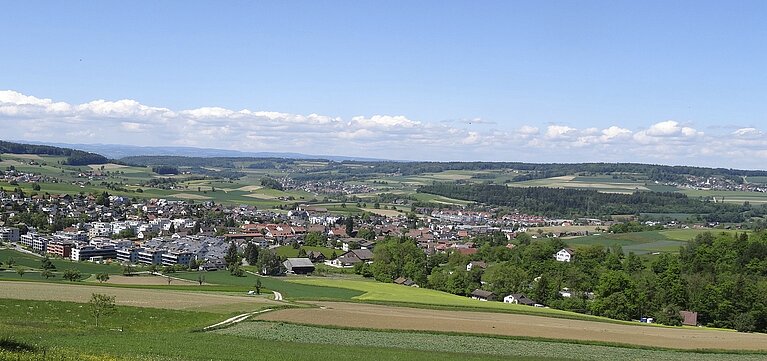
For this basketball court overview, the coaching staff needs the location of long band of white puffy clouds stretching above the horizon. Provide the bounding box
[0,90,767,168]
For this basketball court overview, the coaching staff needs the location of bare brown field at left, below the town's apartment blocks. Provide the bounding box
[0,279,277,313]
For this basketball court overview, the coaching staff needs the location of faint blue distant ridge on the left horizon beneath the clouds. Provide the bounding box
[16,141,390,162]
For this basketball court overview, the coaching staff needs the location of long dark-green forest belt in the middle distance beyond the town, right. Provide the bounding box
[418,183,767,222]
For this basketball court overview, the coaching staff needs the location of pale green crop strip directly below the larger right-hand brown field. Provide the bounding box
[218,321,765,361]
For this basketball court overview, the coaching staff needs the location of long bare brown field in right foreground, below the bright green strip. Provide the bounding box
[259,302,767,350]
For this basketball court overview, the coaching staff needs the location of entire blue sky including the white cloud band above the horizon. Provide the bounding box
[0,0,767,169]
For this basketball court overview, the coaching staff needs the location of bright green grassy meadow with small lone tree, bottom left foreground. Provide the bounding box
[0,299,562,361]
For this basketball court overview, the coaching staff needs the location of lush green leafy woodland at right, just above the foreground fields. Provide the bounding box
[368,232,767,332]
